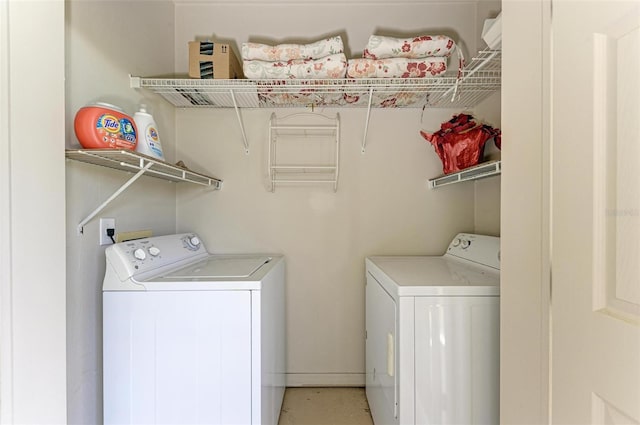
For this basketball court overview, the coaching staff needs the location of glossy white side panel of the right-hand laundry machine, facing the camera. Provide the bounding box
[415,296,500,425]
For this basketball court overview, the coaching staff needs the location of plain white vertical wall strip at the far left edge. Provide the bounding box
[0,0,66,424]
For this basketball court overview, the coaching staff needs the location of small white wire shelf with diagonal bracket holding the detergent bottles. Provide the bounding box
[66,149,222,234]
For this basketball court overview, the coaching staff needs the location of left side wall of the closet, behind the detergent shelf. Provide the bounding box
[65,0,176,424]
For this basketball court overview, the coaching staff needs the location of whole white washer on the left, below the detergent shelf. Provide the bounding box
[103,233,285,425]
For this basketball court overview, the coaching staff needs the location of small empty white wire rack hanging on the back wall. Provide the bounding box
[267,113,340,192]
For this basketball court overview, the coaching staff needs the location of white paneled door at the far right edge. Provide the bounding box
[551,0,640,424]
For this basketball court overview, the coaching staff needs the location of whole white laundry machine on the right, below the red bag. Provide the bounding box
[365,233,500,425]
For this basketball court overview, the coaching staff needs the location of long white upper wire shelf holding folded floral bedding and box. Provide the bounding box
[130,50,502,153]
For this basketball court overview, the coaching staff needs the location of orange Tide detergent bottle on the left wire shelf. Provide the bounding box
[73,102,138,149]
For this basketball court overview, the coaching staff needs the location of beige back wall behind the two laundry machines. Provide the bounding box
[175,1,500,385]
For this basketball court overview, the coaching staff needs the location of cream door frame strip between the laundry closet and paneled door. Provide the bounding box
[500,0,552,424]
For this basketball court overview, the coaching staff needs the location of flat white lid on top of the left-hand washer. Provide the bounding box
[163,256,271,280]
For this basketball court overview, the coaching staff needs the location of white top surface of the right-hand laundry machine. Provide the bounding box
[369,256,500,296]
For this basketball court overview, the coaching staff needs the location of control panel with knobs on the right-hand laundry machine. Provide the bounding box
[447,233,500,270]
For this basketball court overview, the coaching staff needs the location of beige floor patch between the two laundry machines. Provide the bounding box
[278,387,373,425]
